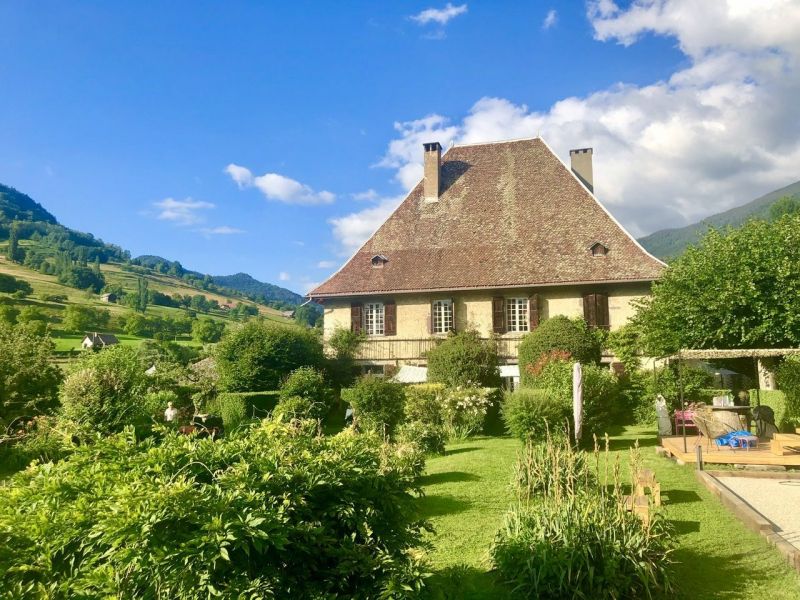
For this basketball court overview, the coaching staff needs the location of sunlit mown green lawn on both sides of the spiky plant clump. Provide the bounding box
[420,428,800,600]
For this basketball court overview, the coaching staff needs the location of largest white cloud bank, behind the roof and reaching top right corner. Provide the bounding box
[374,0,800,237]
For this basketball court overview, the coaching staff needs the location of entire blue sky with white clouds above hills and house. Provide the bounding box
[0,0,800,292]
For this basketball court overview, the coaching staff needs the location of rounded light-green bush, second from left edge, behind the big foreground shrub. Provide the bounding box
[61,346,148,434]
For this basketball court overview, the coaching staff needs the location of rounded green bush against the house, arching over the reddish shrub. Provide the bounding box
[519,315,601,387]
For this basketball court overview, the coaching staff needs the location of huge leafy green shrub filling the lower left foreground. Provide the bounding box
[0,421,432,599]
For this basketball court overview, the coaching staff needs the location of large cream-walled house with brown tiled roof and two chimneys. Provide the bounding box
[308,138,665,365]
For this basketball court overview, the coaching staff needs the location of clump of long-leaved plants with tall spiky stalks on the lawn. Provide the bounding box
[491,437,675,600]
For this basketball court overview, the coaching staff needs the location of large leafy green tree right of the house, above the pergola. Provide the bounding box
[634,214,800,356]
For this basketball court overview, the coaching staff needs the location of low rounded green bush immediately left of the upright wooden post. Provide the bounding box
[501,388,572,441]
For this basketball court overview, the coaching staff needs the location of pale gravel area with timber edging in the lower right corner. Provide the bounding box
[718,477,800,549]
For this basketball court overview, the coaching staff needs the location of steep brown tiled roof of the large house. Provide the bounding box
[309,138,664,298]
